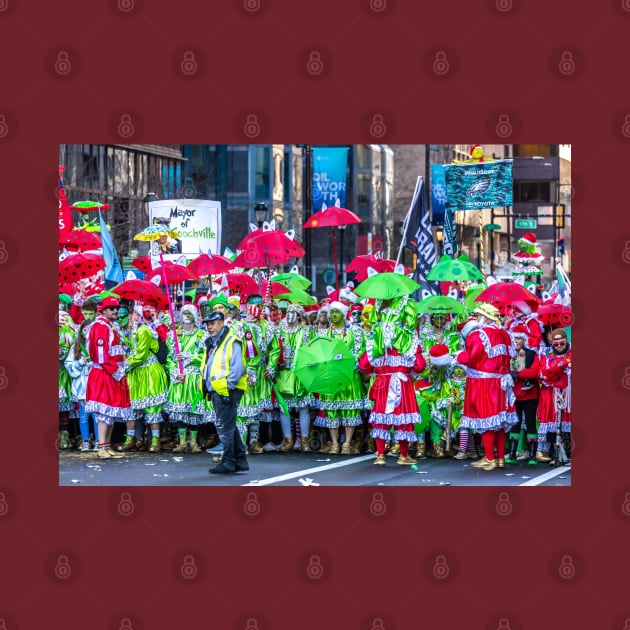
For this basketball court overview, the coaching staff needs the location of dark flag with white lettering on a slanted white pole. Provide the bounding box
[403,177,437,282]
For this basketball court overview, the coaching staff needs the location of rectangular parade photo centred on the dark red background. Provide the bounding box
[55,143,573,488]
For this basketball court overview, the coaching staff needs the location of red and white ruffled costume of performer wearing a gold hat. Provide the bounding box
[456,324,518,433]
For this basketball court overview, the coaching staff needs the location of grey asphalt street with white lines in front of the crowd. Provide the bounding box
[59,451,571,487]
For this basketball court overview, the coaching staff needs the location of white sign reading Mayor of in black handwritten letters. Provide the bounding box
[149,199,221,258]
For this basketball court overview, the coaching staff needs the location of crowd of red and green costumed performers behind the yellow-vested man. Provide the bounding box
[58,254,572,471]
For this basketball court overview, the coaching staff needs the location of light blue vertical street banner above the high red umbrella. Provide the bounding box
[313,147,348,212]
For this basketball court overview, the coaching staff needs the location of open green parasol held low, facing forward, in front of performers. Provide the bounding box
[293,337,355,394]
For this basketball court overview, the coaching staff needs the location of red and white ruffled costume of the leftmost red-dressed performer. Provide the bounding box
[85,316,134,424]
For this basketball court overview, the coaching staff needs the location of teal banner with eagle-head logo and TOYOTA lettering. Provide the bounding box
[444,160,513,210]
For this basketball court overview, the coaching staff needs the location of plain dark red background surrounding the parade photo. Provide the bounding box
[0,0,630,630]
